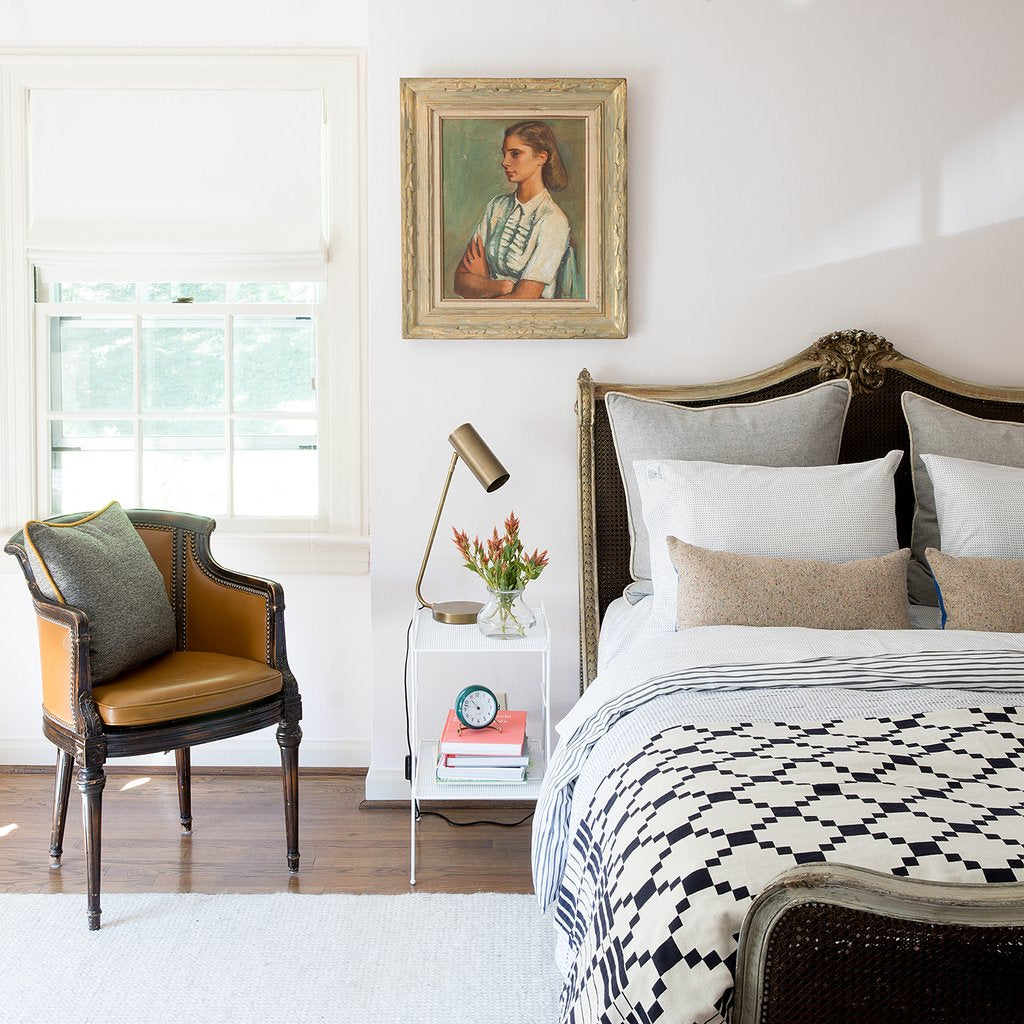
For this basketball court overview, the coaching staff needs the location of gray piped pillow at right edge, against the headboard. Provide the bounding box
[901,391,1024,605]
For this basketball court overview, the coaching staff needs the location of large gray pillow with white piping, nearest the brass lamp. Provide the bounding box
[604,380,851,603]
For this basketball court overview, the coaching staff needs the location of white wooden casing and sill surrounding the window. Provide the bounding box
[0,50,370,573]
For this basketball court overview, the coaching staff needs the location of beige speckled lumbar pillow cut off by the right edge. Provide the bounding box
[925,548,1024,633]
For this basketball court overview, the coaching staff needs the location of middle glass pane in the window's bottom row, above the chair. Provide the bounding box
[142,420,227,515]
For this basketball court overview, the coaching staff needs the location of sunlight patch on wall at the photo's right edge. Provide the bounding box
[938,103,1024,234]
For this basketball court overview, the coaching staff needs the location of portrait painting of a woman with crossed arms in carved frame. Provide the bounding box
[401,78,627,338]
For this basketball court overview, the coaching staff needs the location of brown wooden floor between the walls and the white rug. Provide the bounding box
[0,768,532,894]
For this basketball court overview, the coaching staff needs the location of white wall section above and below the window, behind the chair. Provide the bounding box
[0,0,371,765]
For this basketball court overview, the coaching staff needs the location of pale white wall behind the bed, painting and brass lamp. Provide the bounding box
[368,0,1024,795]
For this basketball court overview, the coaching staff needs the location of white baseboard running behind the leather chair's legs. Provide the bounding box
[0,734,368,770]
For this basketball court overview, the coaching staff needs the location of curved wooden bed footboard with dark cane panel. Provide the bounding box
[732,864,1024,1024]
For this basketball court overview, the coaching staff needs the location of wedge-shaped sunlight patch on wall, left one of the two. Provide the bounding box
[766,177,922,276]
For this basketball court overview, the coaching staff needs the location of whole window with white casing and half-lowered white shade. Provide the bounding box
[0,51,369,571]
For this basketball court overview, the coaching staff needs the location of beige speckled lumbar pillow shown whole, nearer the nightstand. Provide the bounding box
[669,537,910,630]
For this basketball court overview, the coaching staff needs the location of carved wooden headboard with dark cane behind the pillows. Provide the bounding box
[577,331,1024,692]
